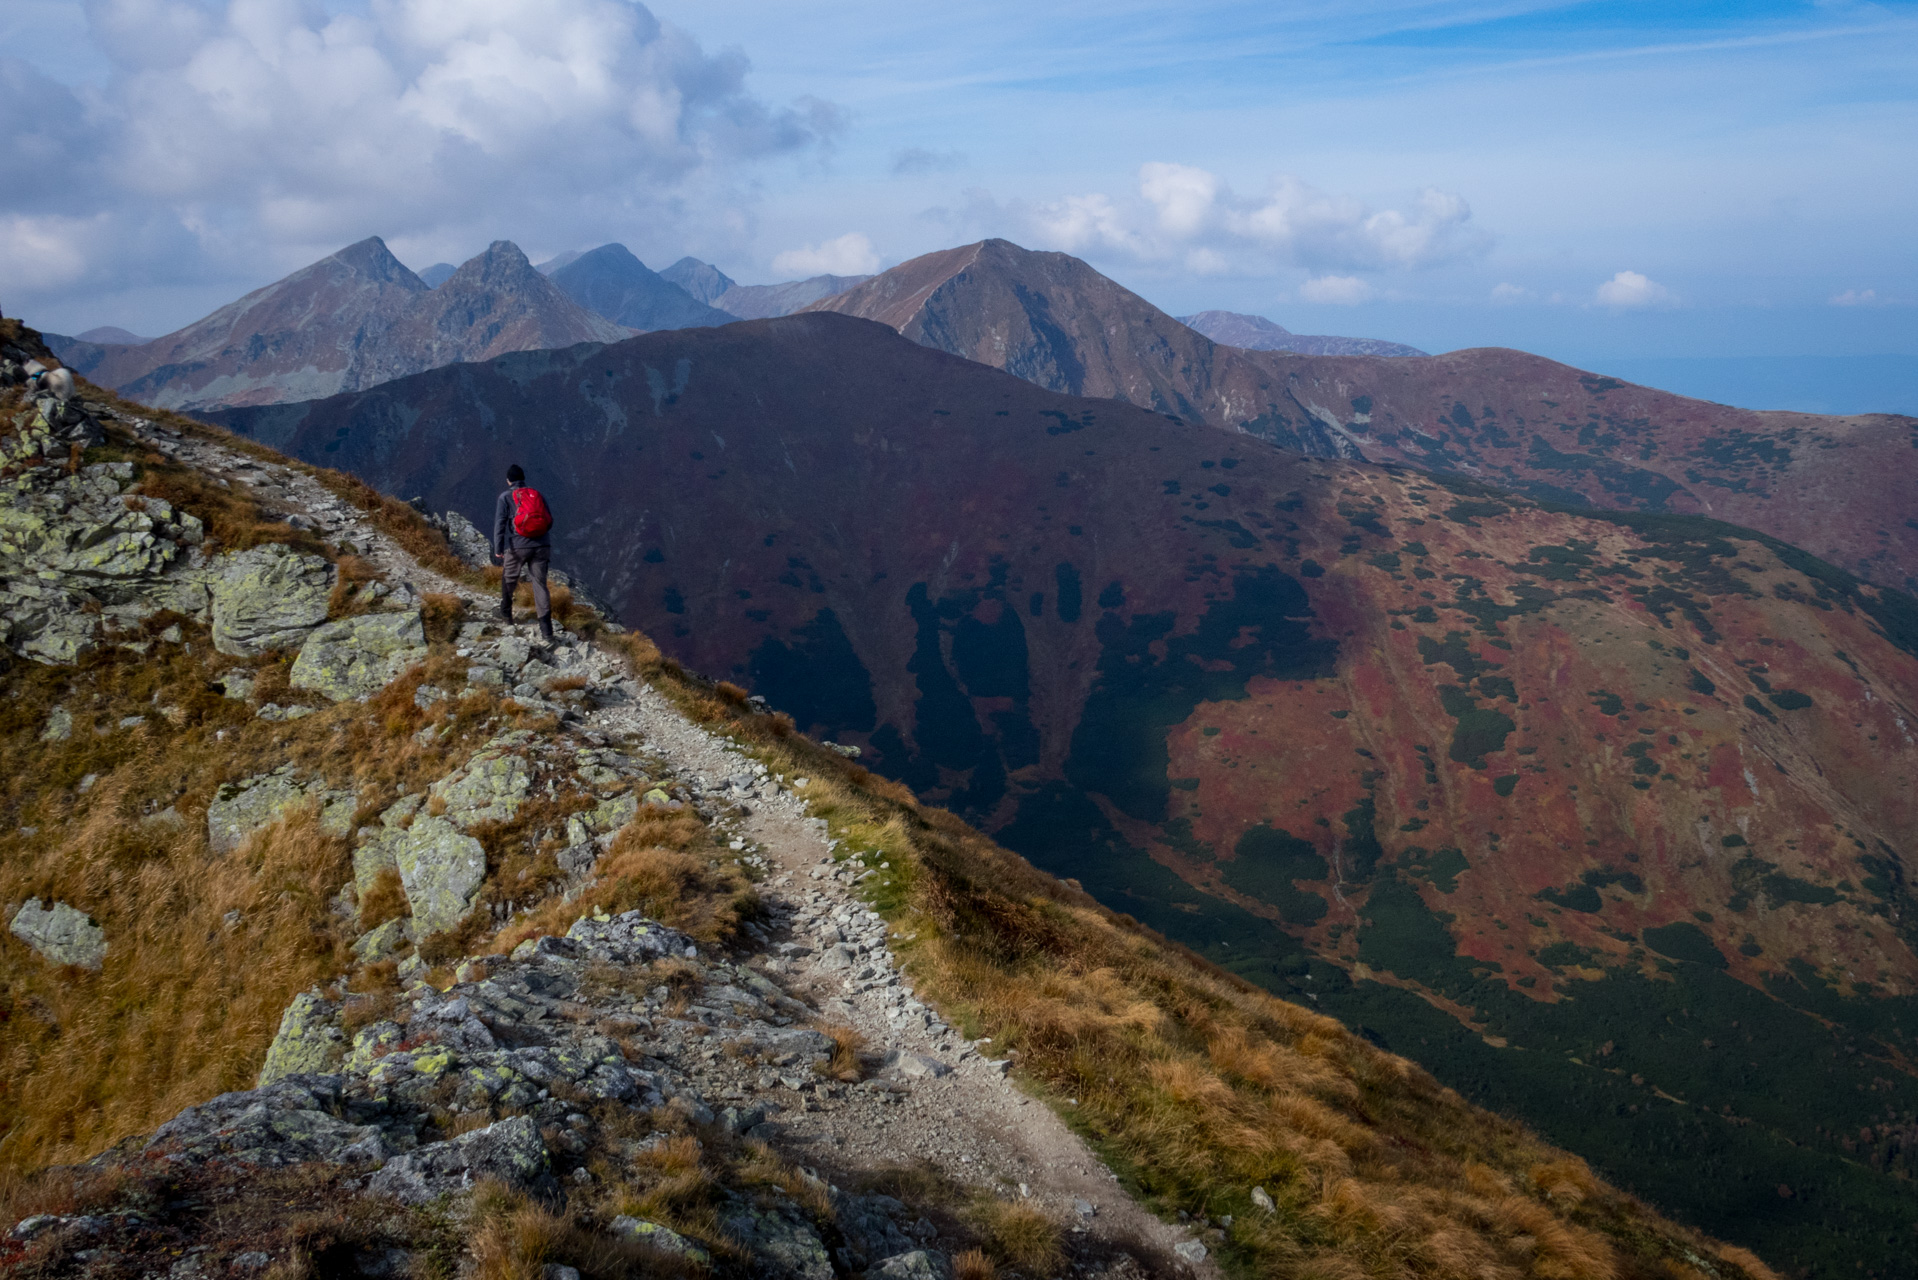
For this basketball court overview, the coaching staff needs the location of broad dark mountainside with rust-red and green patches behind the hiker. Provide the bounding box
[222,313,1918,1274]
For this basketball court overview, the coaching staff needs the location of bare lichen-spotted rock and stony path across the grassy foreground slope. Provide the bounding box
[0,376,1208,1280]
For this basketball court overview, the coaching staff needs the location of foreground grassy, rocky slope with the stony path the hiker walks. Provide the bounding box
[0,320,1774,1280]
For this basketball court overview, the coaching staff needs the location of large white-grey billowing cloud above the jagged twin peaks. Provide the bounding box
[0,0,844,330]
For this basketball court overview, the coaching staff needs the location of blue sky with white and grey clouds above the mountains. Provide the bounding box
[0,0,1918,379]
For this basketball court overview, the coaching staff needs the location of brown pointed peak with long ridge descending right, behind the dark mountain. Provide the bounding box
[815,240,1918,591]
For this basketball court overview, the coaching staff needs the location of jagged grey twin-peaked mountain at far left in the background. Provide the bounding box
[45,236,631,409]
